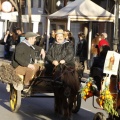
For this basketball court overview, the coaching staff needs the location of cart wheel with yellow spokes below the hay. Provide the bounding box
[10,86,21,112]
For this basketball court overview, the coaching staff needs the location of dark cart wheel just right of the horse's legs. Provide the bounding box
[72,92,81,113]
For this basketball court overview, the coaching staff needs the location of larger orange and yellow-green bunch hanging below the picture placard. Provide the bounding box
[97,86,118,116]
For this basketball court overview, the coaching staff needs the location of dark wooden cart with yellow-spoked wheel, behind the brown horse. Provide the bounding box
[9,70,81,113]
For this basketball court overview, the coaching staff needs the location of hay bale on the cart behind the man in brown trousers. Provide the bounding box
[0,63,22,84]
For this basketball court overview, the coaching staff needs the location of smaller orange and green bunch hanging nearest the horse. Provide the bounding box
[81,77,95,100]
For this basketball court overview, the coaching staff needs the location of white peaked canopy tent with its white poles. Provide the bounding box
[47,0,114,59]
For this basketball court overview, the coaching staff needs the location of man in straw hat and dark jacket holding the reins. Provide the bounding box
[46,29,74,74]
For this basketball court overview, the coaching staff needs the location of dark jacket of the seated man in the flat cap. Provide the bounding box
[12,39,41,68]
